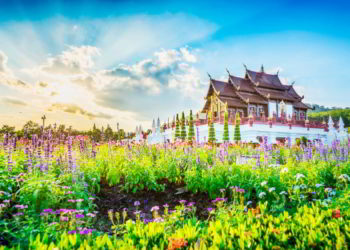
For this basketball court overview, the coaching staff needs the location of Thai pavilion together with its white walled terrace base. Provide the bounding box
[147,66,347,144]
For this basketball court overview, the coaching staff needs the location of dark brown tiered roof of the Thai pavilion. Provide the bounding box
[203,67,311,111]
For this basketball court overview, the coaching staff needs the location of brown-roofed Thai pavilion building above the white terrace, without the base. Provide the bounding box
[202,65,311,121]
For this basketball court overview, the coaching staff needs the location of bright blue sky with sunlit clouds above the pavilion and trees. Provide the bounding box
[0,0,350,130]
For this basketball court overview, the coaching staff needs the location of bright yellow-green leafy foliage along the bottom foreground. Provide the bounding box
[4,201,350,250]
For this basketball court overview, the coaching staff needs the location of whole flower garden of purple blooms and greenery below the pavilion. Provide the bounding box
[0,132,350,249]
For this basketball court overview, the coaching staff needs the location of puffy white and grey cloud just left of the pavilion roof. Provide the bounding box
[100,48,199,95]
